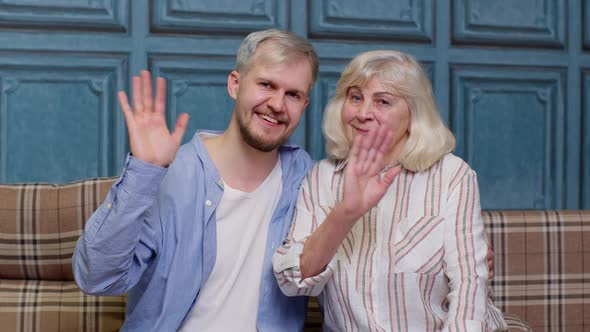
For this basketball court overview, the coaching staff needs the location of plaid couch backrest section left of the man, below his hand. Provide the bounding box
[0,178,116,280]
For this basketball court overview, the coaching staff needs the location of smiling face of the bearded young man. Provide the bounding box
[228,44,313,152]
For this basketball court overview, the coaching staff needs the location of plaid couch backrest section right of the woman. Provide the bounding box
[483,211,590,331]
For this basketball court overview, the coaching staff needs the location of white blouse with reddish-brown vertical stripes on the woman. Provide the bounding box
[273,154,505,332]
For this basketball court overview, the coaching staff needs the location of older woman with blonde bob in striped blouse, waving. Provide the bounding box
[273,51,505,331]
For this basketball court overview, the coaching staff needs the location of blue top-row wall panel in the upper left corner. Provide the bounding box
[0,0,130,32]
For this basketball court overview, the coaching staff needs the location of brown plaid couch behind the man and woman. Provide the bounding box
[0,178,590,332]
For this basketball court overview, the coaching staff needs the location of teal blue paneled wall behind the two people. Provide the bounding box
[0,0,590,209]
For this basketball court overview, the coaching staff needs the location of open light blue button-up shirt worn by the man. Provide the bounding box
[72,133,311,331]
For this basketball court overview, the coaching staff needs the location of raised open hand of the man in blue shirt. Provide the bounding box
[119,70,189,167]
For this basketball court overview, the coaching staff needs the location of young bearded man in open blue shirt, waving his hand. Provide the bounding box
[73,30,318,331]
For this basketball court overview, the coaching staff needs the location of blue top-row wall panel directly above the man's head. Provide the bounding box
[150,0,288,35]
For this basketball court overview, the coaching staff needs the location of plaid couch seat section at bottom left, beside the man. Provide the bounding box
[0,280,126,332]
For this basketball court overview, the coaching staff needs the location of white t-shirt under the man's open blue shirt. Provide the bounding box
[179,159,282,331]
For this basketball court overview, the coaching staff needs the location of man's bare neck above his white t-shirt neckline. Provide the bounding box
[204,125,279,192]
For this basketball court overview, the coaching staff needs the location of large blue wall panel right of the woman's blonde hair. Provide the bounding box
[451,65,566,209]
